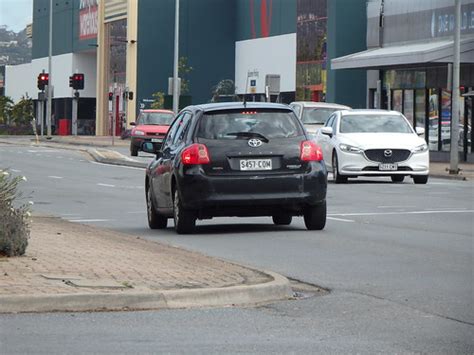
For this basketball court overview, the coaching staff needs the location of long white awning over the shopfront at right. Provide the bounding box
[331,37,474,69]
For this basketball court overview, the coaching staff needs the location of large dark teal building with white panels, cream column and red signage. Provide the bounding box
[6,0,366,135]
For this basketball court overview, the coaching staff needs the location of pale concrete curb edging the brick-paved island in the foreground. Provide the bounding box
[0,271,293,313]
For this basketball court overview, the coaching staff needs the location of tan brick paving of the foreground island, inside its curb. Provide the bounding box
[0,217,271,296]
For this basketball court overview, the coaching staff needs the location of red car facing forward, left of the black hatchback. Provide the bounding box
[130,110,174,157]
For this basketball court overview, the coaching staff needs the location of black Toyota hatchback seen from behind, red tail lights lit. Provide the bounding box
[142,102,327,234]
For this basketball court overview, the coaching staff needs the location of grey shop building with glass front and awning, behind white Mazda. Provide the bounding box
[331,0,474,162]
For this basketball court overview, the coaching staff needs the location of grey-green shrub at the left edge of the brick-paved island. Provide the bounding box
[0,170,30,256]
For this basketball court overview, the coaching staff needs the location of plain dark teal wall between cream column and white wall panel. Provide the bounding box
[137,0,236,110]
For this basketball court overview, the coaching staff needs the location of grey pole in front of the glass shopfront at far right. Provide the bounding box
[449,0,461,174]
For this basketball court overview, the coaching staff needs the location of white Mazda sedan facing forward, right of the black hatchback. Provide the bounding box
[316,109,429,184]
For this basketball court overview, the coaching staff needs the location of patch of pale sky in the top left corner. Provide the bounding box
[0,0,33,32]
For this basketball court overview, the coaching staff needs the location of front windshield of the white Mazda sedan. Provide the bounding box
[339,115,413,133]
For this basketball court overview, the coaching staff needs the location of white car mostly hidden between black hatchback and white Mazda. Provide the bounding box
[290,101,350,136]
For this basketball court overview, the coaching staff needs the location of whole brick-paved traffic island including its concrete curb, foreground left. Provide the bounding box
[0,217,292,313]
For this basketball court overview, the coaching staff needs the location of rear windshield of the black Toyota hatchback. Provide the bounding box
[197,109,304,139]
